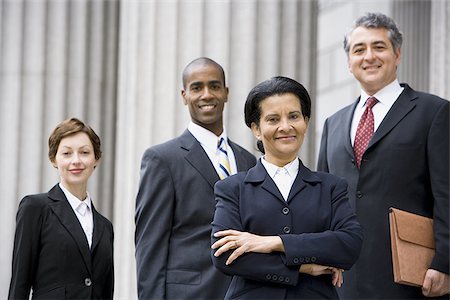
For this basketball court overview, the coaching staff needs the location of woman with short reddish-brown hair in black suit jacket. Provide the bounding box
[8,118,114,299]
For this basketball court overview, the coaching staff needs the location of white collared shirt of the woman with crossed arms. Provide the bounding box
[261,157,300,201]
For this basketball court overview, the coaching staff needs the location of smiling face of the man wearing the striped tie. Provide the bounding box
[181,64,228,136]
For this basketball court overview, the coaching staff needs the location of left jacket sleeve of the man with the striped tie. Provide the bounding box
[135,149,175,299]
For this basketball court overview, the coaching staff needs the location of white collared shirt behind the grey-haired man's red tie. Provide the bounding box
[350,79,404,145]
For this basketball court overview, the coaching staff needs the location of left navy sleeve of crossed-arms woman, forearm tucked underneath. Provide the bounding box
[211,180,299,285]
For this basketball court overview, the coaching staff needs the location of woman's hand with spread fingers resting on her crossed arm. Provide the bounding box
[211,229,284,265]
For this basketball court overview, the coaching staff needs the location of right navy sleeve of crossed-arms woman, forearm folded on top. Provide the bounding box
[280,174,363,270]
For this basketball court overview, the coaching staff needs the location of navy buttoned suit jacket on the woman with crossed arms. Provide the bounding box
[211,161,362,299]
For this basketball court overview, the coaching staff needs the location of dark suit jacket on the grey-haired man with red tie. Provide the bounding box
[318,85,449,299]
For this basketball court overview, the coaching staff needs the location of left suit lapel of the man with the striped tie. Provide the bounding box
[180,130,219,188]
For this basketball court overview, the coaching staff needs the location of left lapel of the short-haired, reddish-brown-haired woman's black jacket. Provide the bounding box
[48,185,92,272]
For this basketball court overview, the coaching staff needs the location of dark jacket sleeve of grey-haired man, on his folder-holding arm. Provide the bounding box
[427,101,450,274]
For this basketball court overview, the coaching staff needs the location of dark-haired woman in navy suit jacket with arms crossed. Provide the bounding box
[211,77,362,299]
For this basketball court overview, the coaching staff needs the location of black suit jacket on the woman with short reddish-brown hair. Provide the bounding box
[8,185,114,300]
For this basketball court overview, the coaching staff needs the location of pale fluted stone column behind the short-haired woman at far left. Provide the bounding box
[0,0,118,299]
